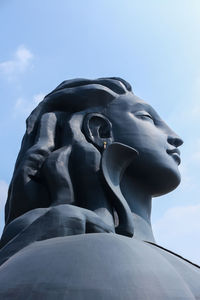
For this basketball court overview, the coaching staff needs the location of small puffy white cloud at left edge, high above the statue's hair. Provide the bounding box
[0,45,33,79]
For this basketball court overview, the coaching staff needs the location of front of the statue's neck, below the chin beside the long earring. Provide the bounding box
[120,172,155,242]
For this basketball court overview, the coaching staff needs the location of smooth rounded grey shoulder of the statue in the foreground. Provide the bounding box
[0,233,198,300]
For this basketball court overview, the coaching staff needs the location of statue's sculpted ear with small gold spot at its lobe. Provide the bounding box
[83,113,113,150]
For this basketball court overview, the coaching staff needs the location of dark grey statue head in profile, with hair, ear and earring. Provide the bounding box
[6,77,183,236]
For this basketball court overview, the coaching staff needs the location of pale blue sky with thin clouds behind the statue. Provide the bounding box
[0,0,200,264]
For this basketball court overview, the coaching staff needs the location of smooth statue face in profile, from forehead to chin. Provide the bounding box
[106,93,183,196]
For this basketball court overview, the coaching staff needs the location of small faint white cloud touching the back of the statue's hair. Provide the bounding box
[14,93,45,117]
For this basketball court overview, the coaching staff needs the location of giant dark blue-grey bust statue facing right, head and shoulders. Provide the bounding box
[0,77,200,300]
